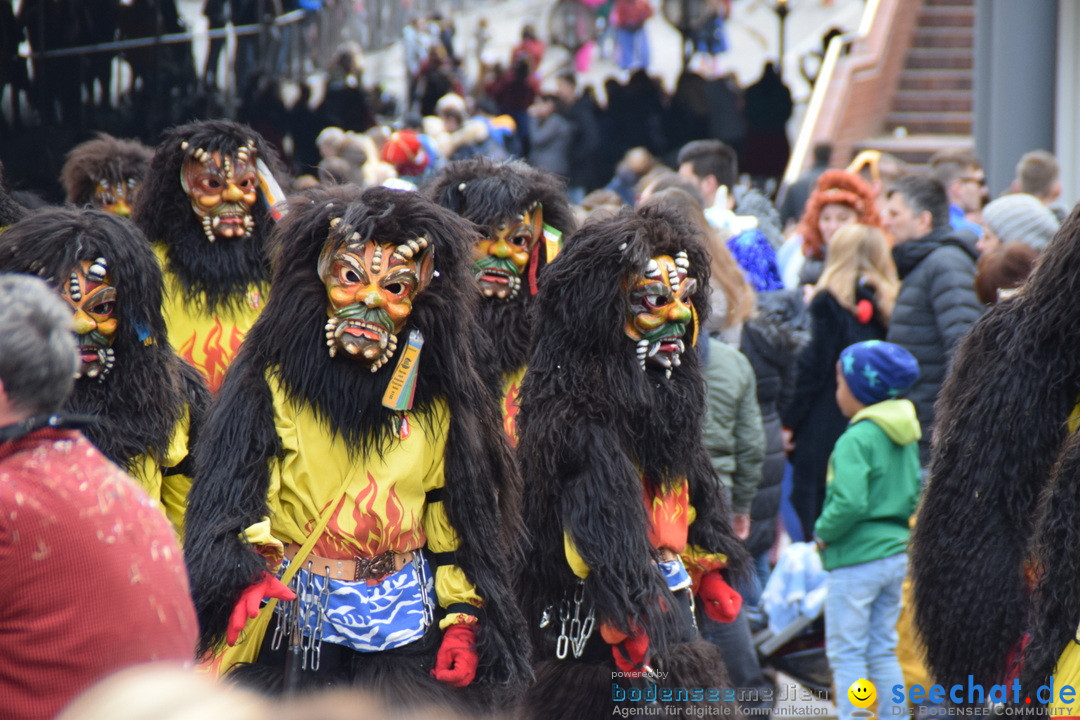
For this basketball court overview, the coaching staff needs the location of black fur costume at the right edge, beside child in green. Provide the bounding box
[912,205,1080,702]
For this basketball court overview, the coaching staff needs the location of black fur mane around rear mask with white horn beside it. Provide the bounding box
[133,120,285,312]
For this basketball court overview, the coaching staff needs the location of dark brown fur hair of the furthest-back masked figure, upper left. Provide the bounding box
[60,133,153,205]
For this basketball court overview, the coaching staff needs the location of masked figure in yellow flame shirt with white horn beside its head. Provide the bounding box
[134,120,282,392]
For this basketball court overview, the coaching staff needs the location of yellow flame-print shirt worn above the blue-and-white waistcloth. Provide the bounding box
[244,373,483,628]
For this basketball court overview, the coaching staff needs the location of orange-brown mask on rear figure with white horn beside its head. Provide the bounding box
[180,141,259,243]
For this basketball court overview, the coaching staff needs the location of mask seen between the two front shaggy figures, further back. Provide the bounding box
[473,205,543,300]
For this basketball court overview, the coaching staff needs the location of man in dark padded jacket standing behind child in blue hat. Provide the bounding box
[885,175,983,467]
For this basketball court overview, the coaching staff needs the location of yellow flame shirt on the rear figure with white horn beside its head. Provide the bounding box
[153,243,266,393]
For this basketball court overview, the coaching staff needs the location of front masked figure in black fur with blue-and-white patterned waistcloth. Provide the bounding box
[186,186,530,706]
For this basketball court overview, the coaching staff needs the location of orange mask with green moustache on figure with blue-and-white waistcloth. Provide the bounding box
[319,218,434,372]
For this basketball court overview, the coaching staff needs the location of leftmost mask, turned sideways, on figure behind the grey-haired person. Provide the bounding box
[60,258,120,380]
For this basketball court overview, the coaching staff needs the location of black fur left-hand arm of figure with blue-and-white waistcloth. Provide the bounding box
[184,351,281,654]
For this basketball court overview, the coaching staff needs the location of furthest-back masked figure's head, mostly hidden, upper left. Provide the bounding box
[60,133,153,217]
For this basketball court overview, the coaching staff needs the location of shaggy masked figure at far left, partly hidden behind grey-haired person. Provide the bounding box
[0,208,210,533]
